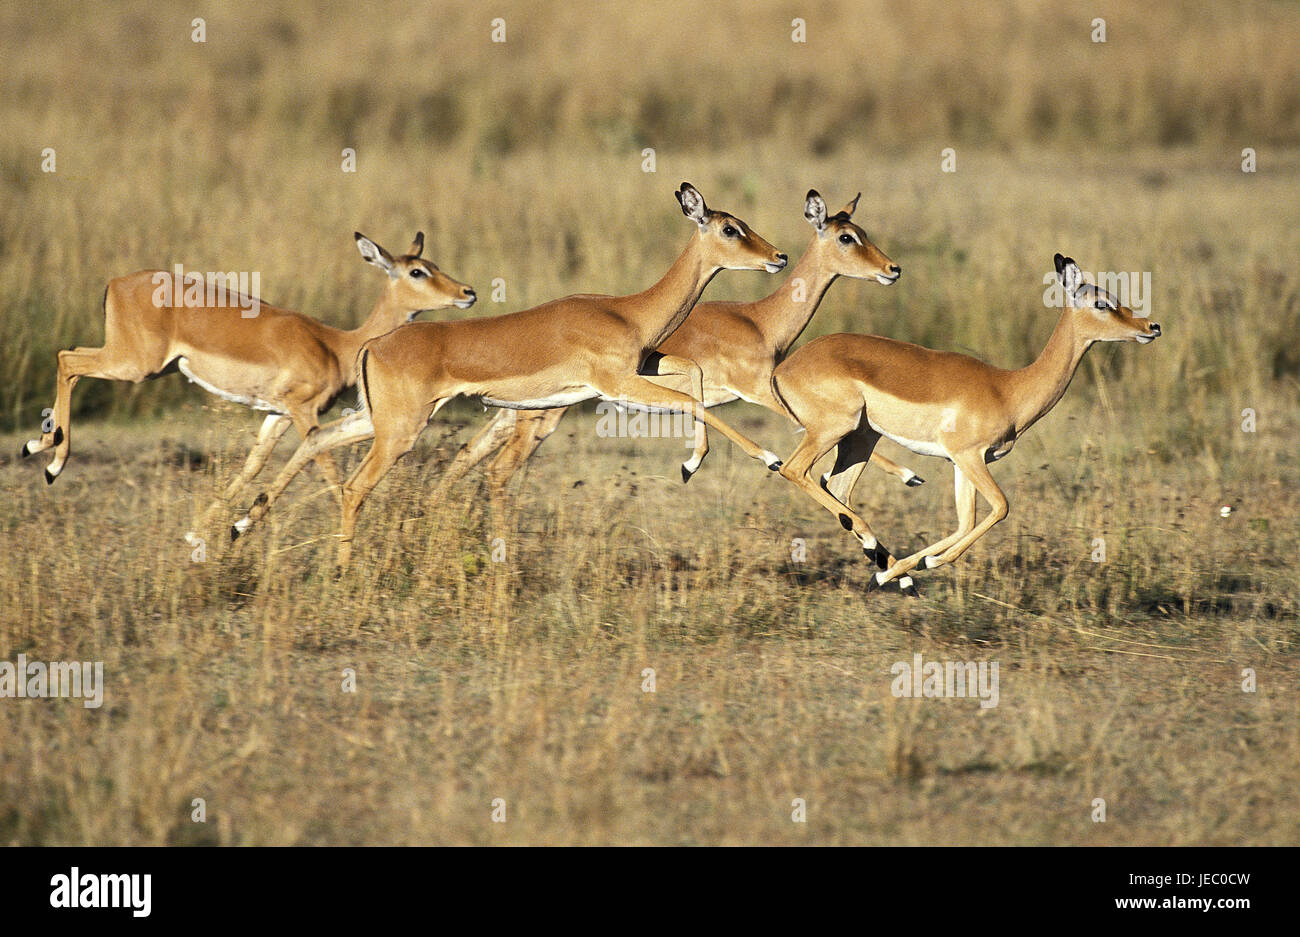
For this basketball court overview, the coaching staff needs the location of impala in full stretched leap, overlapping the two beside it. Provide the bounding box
[231,182,787,568]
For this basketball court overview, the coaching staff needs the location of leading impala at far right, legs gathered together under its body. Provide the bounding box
[772,253,1160,593]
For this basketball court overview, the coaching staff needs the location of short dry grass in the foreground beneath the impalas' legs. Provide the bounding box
[0,389,1300,843]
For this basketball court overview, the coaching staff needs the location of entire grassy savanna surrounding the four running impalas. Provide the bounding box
[0,3,1300,845]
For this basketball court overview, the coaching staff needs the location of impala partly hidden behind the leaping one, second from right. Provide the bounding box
[432,190,923,502]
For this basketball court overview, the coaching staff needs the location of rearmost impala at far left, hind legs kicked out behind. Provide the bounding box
[22,233,475,532]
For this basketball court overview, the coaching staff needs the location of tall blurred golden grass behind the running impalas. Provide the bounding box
[0,3,1300,429]
